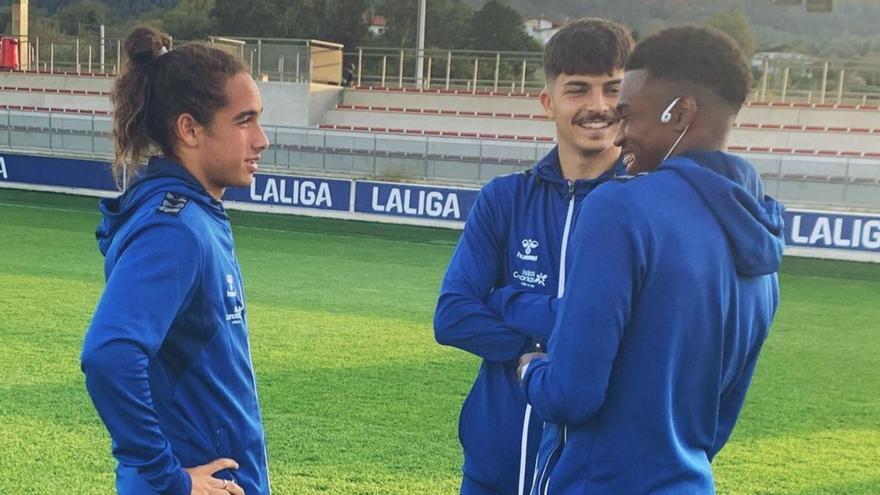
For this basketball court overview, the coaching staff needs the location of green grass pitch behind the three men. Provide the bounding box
[0,190,880,495]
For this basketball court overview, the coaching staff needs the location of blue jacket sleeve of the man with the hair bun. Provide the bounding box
[81,220,202,495]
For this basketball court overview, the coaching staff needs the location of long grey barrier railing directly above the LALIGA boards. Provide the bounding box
[0,110,880,210]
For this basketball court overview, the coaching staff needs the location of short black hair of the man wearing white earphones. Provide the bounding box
[626,26,752,111]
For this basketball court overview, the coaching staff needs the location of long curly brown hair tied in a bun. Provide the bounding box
[110,26,247,186]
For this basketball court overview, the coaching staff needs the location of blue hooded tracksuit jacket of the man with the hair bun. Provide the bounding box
[82,158,269,495]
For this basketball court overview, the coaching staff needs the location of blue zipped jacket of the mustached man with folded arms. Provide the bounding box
[434,148,624,495]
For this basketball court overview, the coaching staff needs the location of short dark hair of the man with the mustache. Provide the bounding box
[544,17,635,81]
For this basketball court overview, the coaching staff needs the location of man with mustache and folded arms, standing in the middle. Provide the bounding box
[434,18,633,495]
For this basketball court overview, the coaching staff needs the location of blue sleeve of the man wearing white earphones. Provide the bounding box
[522,187,646,425]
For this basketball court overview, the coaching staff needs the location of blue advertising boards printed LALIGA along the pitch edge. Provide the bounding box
[0,153,880,262]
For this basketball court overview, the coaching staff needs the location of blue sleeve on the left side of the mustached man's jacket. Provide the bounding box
[434,181,530,361]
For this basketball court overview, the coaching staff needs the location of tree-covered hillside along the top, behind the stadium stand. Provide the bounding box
[0,0,880,60]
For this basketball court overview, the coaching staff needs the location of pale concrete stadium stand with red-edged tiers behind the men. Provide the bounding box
[0,73,880,209]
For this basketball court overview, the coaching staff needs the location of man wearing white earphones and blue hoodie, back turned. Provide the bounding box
[519,27,783,495]
